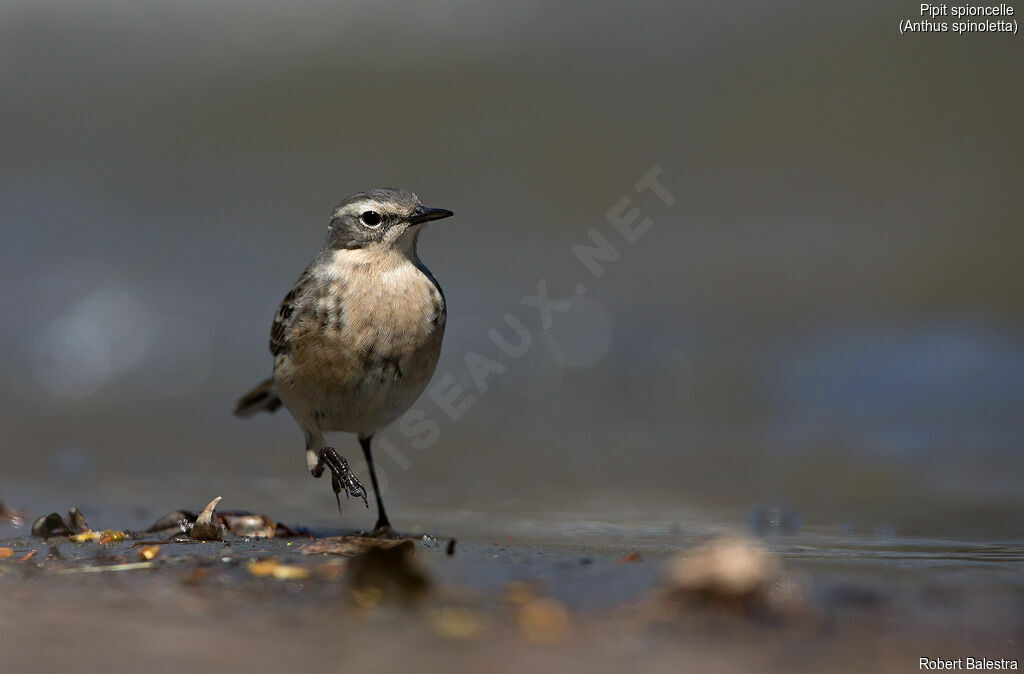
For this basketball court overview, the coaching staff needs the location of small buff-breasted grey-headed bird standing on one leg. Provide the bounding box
[234,187,454,536]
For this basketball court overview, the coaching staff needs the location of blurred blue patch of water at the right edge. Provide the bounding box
[767,320,1024,459]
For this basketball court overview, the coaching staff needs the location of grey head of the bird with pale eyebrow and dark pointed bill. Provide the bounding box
[327,187,454,256]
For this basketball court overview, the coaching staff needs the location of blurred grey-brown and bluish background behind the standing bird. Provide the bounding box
[0,0,1024,539]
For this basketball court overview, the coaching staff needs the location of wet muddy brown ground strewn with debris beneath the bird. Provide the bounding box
[0,495,1024,672]
